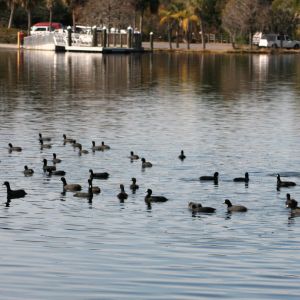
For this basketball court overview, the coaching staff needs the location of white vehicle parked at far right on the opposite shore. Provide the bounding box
[258,33,300,49]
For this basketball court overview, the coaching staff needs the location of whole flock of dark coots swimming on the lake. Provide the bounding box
[3,133,300,215]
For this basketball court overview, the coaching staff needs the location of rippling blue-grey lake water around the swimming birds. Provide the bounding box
[0,50,300,300]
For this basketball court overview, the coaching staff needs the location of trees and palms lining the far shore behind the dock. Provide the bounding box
[0,0,300,48]
